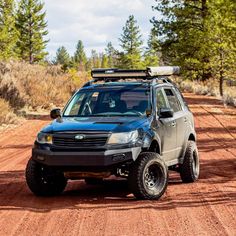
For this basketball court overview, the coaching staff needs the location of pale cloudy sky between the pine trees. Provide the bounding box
[44,0,157,58]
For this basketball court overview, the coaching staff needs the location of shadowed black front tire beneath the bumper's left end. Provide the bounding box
[25,158,67,196]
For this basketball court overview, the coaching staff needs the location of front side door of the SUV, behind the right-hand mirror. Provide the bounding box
[156,88,176,162]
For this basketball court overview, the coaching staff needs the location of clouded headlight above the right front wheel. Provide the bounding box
[107,130,139,144]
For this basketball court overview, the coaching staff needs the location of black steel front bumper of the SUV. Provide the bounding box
[32,147,141,167]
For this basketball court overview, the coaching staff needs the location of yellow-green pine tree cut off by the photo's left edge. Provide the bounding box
[0,0,18,60]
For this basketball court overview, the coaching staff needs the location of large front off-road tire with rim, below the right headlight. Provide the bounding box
[128,152,168,200]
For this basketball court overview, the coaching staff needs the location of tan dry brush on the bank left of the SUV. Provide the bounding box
[0,61,89,125]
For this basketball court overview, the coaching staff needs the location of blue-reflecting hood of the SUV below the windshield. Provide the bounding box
[42,117,147,133]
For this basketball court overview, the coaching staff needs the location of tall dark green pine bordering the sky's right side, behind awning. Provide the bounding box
[151,0,212,80]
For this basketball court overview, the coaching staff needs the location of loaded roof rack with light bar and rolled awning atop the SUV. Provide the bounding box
[83,66,180,87]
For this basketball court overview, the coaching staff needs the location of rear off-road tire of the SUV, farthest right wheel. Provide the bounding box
[179,141,200,183]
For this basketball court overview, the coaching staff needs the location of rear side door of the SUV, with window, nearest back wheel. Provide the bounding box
[164,88,186,158]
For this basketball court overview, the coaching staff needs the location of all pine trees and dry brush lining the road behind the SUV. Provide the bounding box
[0,0,236,124]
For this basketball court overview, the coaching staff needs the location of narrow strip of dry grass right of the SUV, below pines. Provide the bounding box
[175,78,236,106]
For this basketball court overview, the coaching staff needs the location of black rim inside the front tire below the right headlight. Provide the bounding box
[144,163,163,191]
